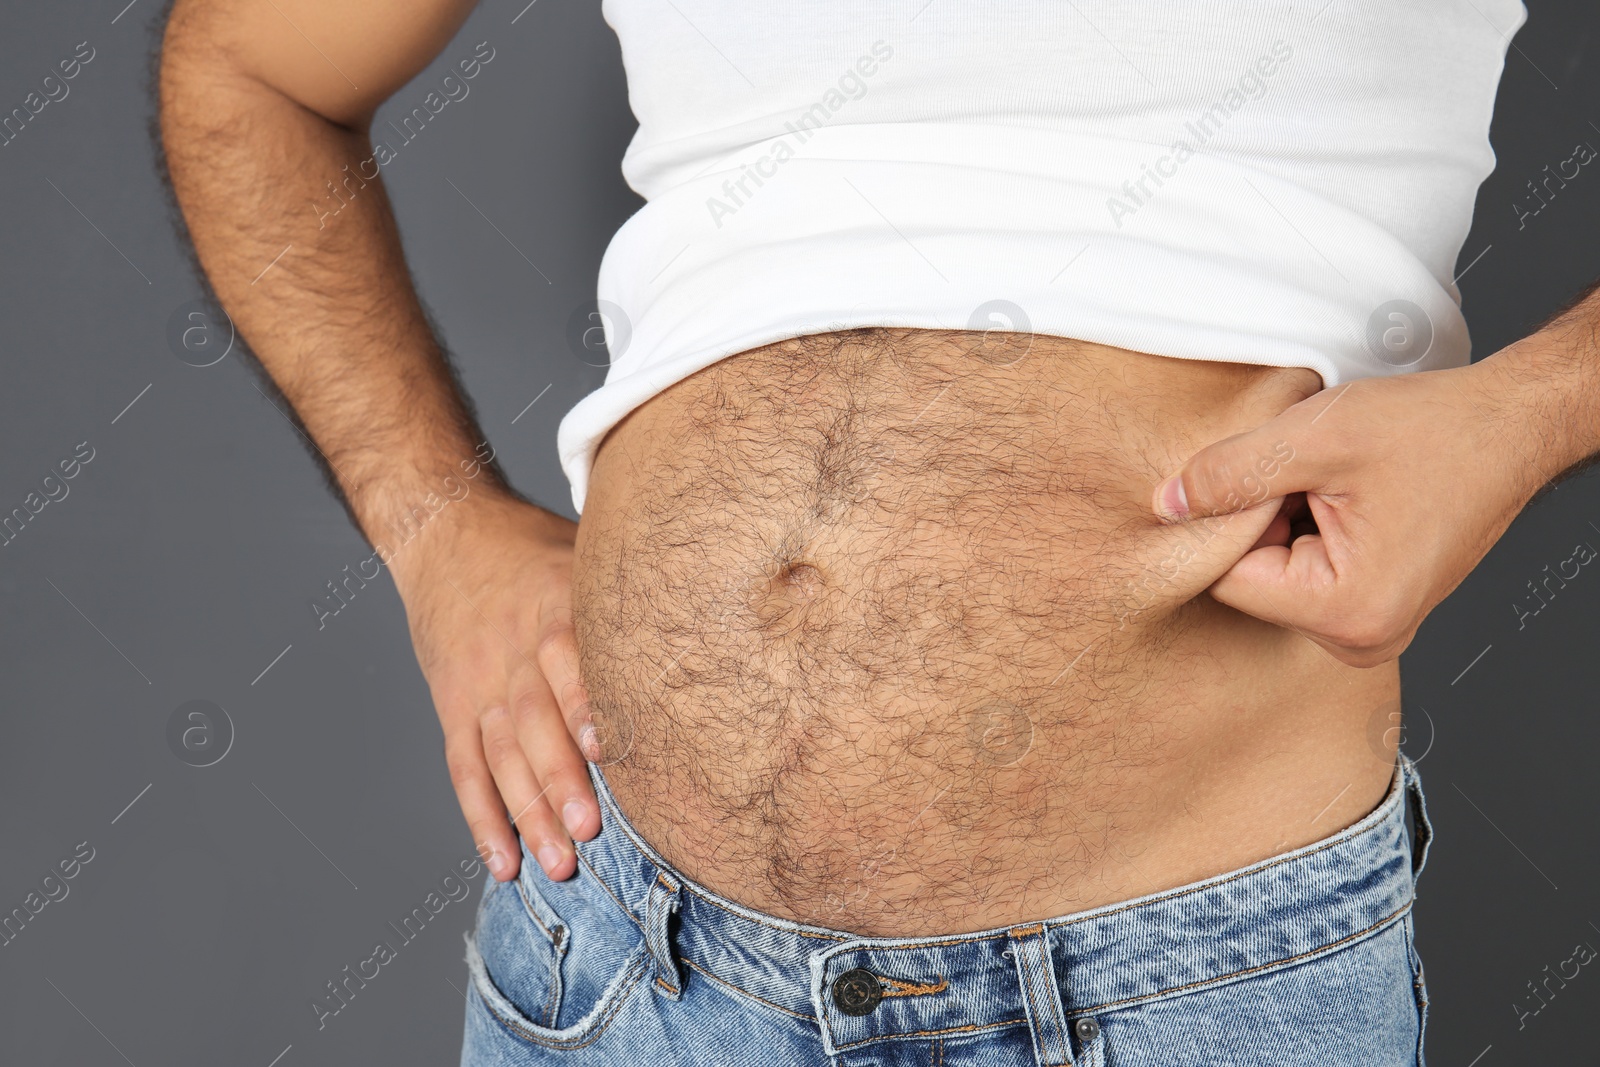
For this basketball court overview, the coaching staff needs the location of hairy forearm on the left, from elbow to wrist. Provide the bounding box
[162,24,544,563]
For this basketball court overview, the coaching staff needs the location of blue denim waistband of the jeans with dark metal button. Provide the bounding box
[578,757,1430,1054]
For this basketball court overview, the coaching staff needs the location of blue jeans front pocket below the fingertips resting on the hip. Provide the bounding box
[467,831,650,1048]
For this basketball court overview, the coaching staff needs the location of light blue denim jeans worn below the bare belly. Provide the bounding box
[461,757,1430,1067]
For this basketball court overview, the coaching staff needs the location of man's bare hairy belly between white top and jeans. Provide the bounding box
[574,330,1398,936]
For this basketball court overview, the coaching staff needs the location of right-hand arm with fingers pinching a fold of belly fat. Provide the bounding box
[1152,290,1600,667]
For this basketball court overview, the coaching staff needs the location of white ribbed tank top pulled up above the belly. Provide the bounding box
[558,0,1526,510]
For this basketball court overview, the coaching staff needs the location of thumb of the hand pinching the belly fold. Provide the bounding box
[1152,416,1325,523]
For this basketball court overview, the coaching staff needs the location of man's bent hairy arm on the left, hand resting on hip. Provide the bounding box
[160,0,600,880]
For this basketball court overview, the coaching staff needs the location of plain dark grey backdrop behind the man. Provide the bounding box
[0,0,1600,1067]
